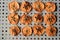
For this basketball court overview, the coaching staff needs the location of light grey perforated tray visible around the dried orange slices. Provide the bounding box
[0,0,60,40]
